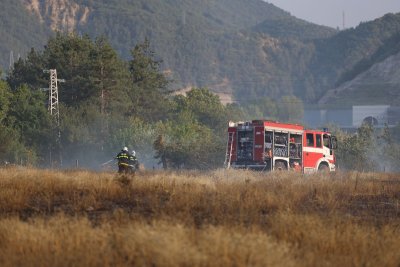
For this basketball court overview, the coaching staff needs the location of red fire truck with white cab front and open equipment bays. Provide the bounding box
[225,120,337,173]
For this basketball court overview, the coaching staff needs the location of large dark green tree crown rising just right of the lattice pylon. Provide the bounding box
[43,33,128,113]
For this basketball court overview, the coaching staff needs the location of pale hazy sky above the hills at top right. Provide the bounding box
[265,0,400,28]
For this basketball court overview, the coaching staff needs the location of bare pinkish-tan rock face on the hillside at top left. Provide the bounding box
[22,0,90,32]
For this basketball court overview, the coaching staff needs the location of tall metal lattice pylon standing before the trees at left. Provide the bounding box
[43,69,65,166]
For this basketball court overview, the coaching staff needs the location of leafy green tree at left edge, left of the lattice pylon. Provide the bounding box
[0,81,50,164]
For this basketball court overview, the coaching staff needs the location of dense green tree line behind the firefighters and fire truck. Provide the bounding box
[0,33,398,172]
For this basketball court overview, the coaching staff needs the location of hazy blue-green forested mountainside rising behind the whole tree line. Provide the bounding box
[0,0,400,103]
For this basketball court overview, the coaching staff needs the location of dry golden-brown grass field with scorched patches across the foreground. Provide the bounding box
[0,168,400,267]
